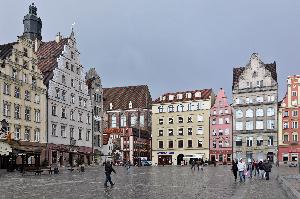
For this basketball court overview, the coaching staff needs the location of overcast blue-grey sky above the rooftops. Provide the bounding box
[0,0,300,99]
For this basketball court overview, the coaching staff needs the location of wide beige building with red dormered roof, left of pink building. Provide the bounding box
[152,89,215,165]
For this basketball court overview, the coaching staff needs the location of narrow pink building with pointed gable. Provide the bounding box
[209,88,232,163]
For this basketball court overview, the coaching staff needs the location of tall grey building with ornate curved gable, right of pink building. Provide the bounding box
[232,53,278,161]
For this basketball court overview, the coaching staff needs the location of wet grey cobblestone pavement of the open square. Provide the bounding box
[0,166,287,199]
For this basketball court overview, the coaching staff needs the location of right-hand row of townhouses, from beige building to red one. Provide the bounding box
[151,53,300,165]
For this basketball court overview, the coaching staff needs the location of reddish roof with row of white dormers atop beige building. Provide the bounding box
[154,89,212,103]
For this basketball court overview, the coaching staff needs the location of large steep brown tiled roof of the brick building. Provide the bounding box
[103,85,152,111]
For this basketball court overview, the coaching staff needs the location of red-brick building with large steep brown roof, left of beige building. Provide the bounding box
[103,85,152,164]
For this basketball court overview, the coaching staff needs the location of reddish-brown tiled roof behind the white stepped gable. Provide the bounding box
[37,38,68,85]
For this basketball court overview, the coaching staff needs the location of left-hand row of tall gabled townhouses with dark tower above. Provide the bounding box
[0,4,103,168]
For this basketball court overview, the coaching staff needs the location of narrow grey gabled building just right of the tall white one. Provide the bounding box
[85,68,103,163]
